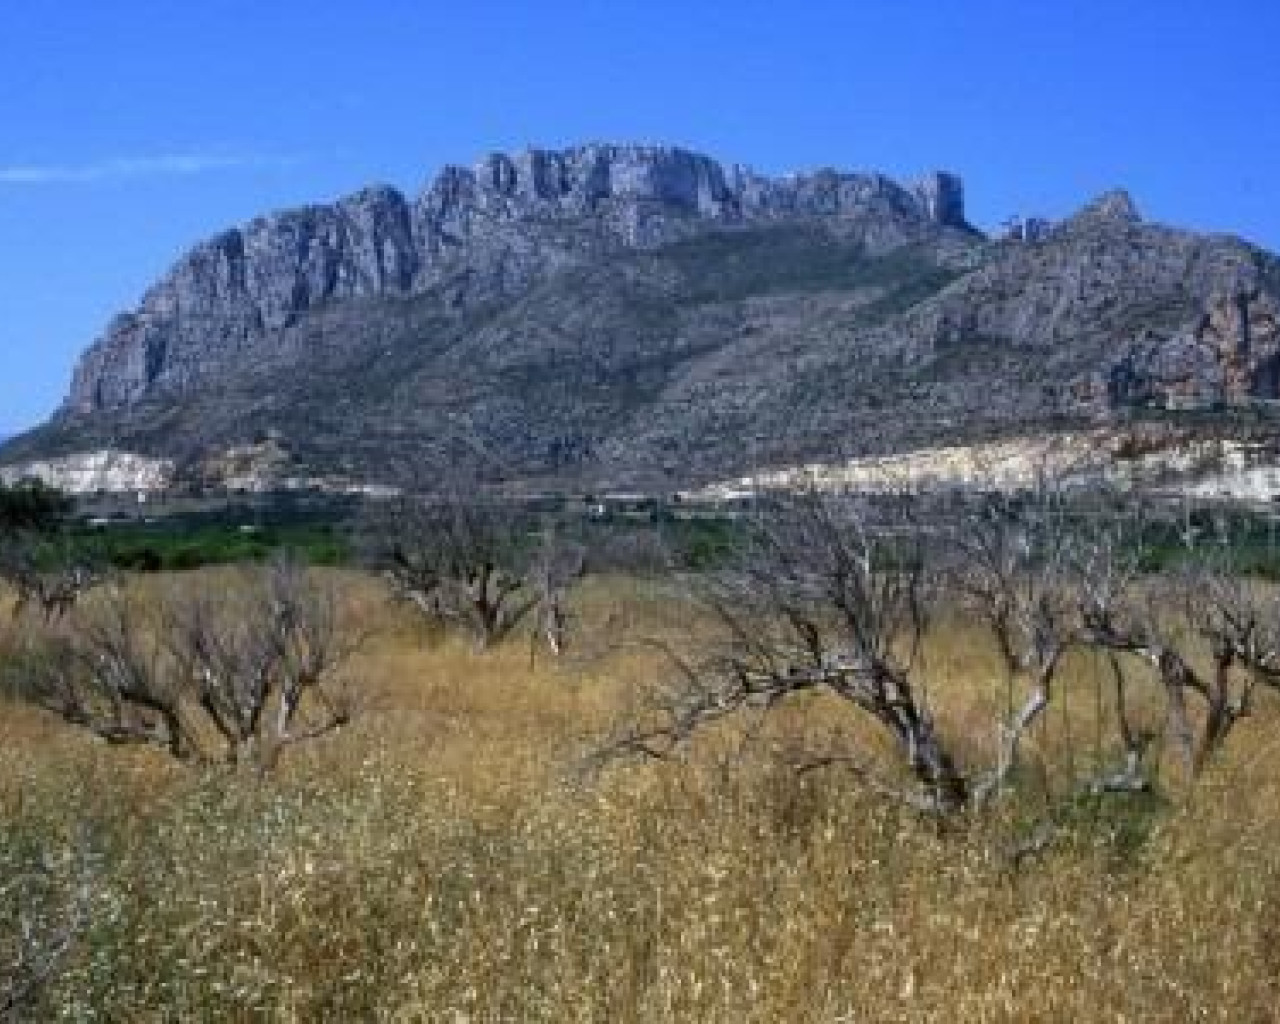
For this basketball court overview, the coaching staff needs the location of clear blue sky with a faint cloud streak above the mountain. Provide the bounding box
[0,0,1280,433]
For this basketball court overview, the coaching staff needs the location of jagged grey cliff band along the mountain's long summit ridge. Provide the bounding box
[64,145,968,413]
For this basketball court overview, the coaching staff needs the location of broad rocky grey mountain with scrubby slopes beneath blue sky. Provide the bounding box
[0,145,1280,488]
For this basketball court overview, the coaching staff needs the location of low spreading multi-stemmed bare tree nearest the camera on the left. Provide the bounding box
[13,561,353,768]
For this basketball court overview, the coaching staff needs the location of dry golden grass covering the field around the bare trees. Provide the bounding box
[0,575,1280,1024]
